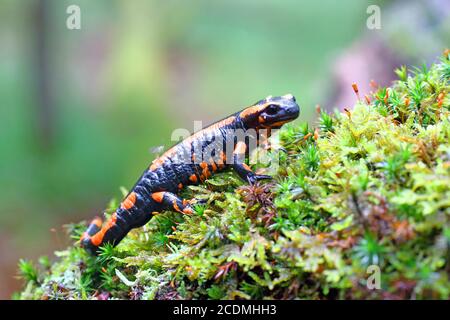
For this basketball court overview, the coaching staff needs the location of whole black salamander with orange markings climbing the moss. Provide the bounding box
[81,94,300,254]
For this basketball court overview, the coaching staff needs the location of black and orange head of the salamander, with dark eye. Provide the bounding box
[239,94,300,129]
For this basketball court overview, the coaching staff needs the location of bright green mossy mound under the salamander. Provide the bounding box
[15,53,450,299]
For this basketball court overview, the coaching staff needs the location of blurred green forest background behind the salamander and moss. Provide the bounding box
[0,0,450,298]
